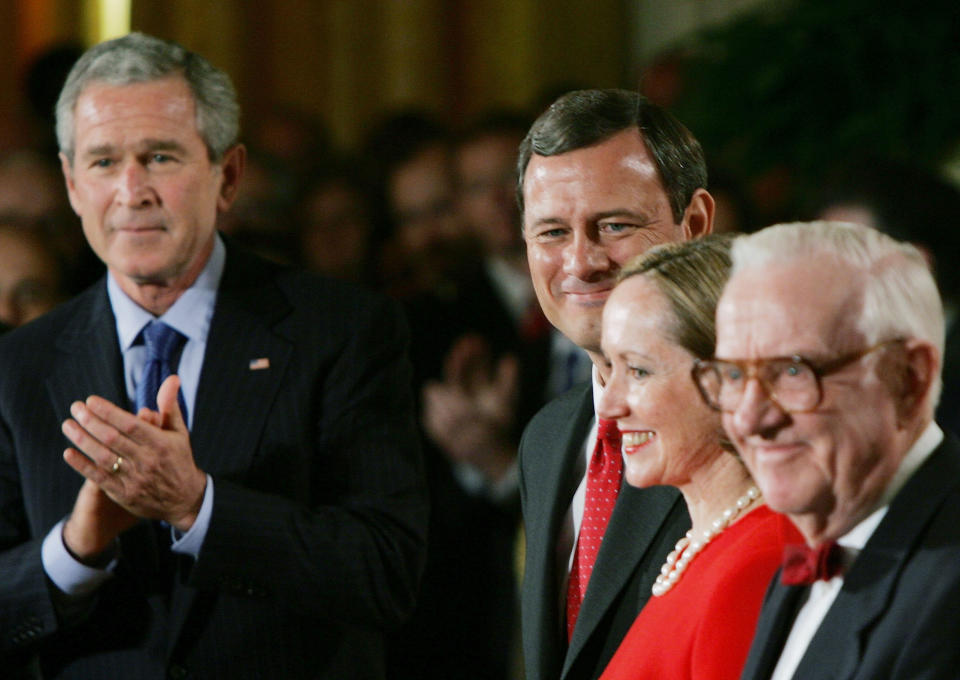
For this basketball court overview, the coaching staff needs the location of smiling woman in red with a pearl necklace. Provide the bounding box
[598,235,799,680]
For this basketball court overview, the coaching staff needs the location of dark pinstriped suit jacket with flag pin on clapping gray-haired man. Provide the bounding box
[0,244,426,678]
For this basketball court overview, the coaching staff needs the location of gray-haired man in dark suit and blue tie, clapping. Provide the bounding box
[0,34,426,678]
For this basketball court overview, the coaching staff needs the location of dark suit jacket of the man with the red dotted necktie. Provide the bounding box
[520,383,690,680]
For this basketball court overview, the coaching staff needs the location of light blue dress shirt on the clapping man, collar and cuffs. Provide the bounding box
[41,235,226,596]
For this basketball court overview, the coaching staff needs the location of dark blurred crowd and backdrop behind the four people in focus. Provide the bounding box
[0,0,960,678]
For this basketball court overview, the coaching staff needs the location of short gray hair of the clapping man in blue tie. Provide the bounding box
[56,33,240,163]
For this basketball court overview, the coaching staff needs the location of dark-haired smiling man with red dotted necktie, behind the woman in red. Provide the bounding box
[518,90,713,680]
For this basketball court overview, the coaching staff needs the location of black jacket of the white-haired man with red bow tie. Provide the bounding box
[742,432,960,680]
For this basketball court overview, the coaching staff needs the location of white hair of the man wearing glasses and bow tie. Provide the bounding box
[730,221,944,406]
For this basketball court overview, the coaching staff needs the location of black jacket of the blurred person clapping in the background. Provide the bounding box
[387,264,550,680]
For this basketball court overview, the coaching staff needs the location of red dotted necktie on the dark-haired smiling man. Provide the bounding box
[567,418,623,641]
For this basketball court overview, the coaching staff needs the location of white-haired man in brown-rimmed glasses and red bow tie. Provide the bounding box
[698,222,960,680]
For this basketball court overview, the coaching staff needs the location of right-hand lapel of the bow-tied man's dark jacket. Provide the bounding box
[797,439,960,678]
